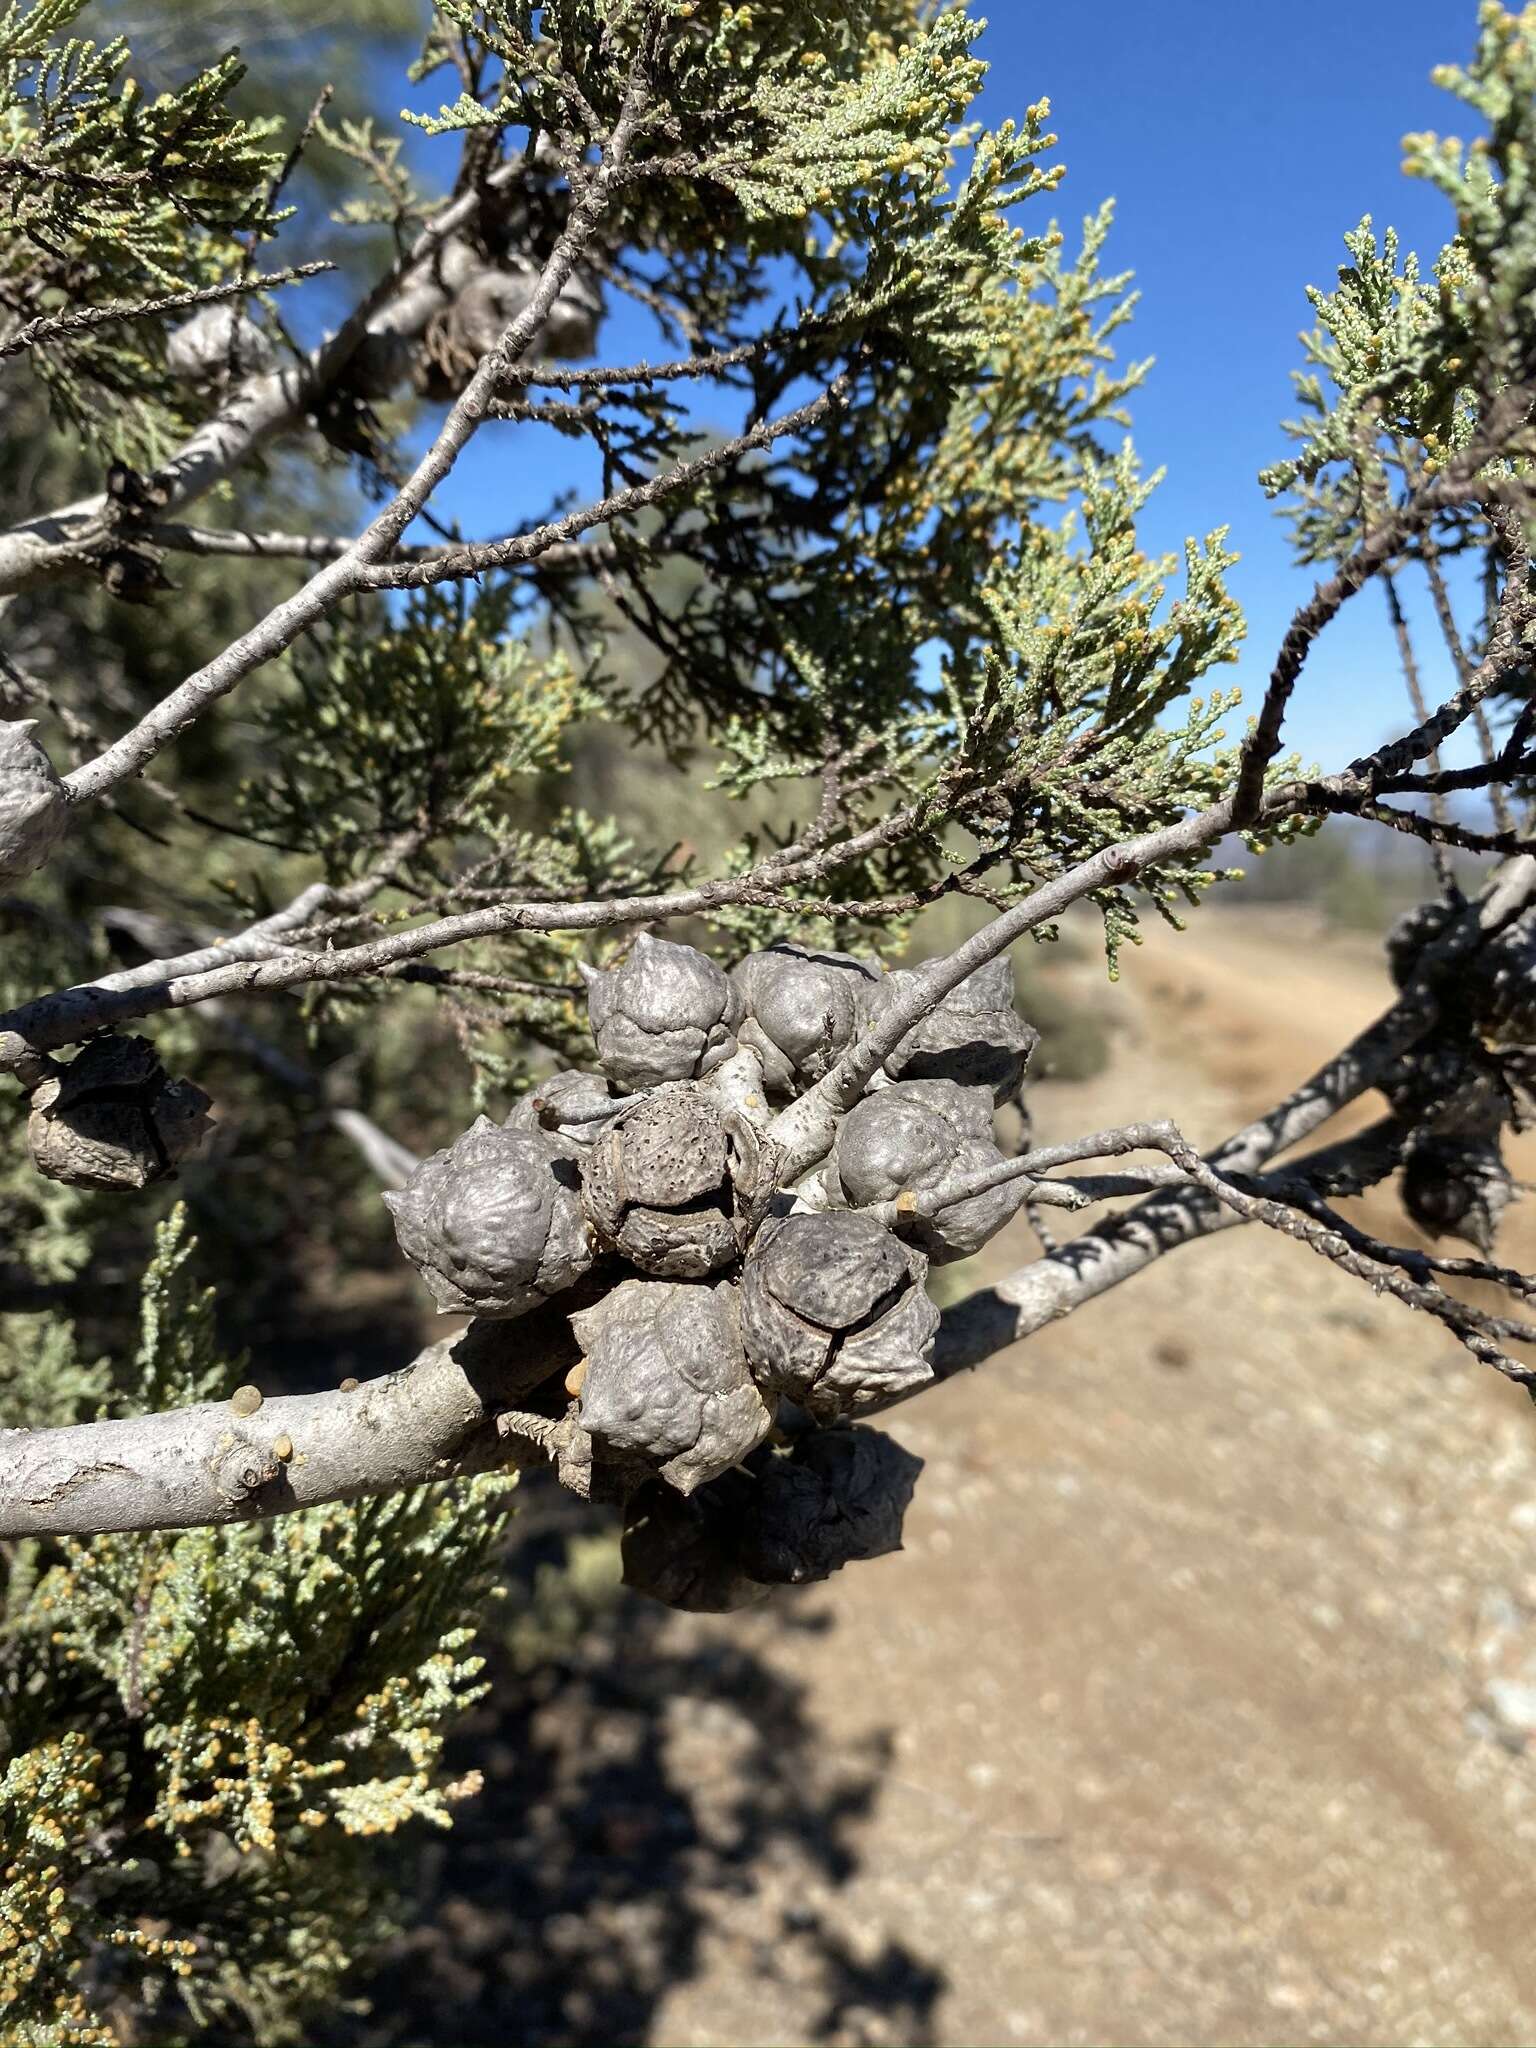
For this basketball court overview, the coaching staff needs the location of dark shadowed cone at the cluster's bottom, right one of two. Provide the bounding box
[735,1423,924,1585]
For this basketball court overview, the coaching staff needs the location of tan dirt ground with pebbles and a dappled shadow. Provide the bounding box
[354,911,1536,2048]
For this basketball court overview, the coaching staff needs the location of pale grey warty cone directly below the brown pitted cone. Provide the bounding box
[571,1280,772,1493]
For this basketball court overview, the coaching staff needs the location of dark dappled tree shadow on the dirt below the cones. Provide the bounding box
[327,1487,944,2048]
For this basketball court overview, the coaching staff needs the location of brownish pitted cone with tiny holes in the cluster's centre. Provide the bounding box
[584,1081,756,1280]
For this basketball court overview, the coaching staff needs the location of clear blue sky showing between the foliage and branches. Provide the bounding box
[405,0,1477,766]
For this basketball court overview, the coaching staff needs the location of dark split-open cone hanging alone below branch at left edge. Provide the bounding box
[27,1036,213,1188]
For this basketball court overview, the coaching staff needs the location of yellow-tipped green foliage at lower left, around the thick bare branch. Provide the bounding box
[0,1214,510,2044]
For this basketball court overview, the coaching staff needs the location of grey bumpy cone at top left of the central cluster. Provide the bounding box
[584,932,741,1092]
